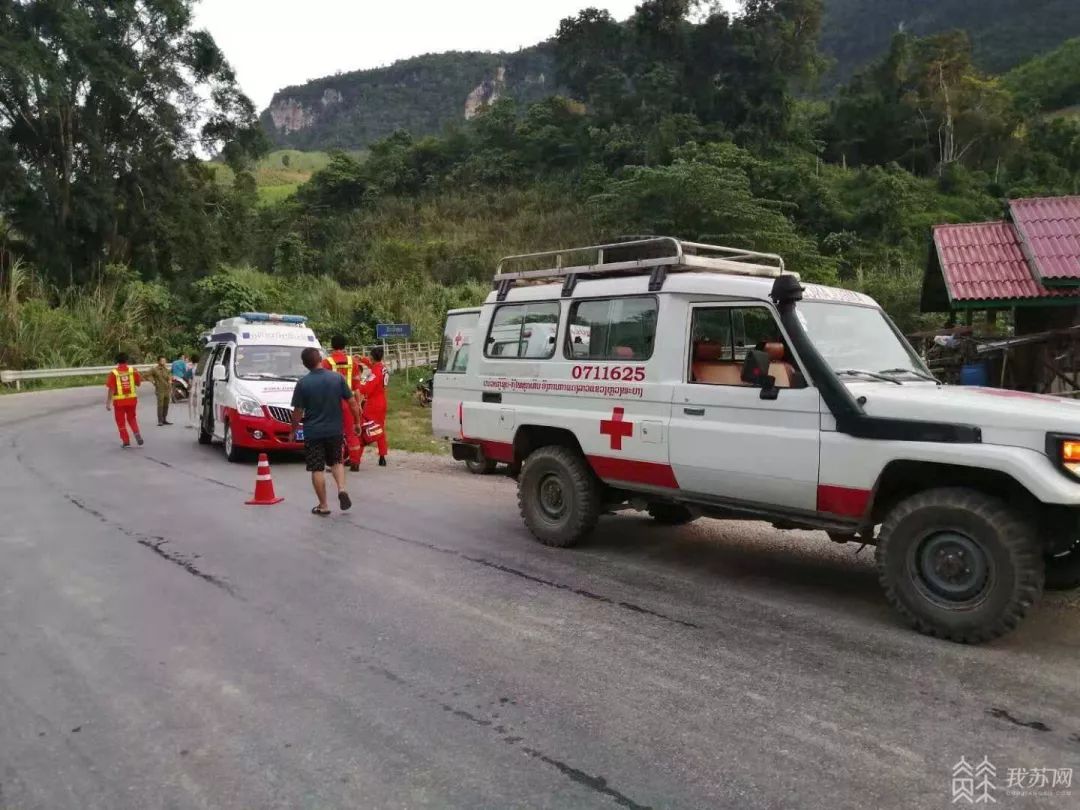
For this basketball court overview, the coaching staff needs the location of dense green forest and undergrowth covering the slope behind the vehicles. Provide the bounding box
[0,0,1080,366]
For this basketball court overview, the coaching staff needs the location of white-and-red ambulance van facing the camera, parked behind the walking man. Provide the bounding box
[194,312,321,461]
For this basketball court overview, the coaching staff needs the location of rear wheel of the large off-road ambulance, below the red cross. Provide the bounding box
[517,445,600,549]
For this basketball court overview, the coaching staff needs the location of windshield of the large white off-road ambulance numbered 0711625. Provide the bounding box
[796,301,926,374]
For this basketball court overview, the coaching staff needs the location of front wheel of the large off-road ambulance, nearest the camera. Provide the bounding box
[877,488,1044,644]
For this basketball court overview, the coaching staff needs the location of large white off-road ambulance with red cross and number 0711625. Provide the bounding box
[432,238,1080,643]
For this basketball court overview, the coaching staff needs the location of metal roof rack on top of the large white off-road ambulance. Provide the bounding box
[495,237,785,301]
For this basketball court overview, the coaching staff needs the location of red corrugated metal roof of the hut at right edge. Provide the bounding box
[922,197,1080,313]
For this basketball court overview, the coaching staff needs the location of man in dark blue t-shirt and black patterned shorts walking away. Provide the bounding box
[289,348,363,516]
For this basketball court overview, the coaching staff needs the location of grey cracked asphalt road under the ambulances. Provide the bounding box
[0,390,1080,810]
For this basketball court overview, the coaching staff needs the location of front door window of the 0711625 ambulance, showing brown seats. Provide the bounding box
[689,307,806,388]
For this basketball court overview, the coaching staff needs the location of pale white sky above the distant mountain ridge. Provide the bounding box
[195,0,738,110]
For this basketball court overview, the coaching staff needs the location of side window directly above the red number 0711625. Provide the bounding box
[566,296,658,360]
